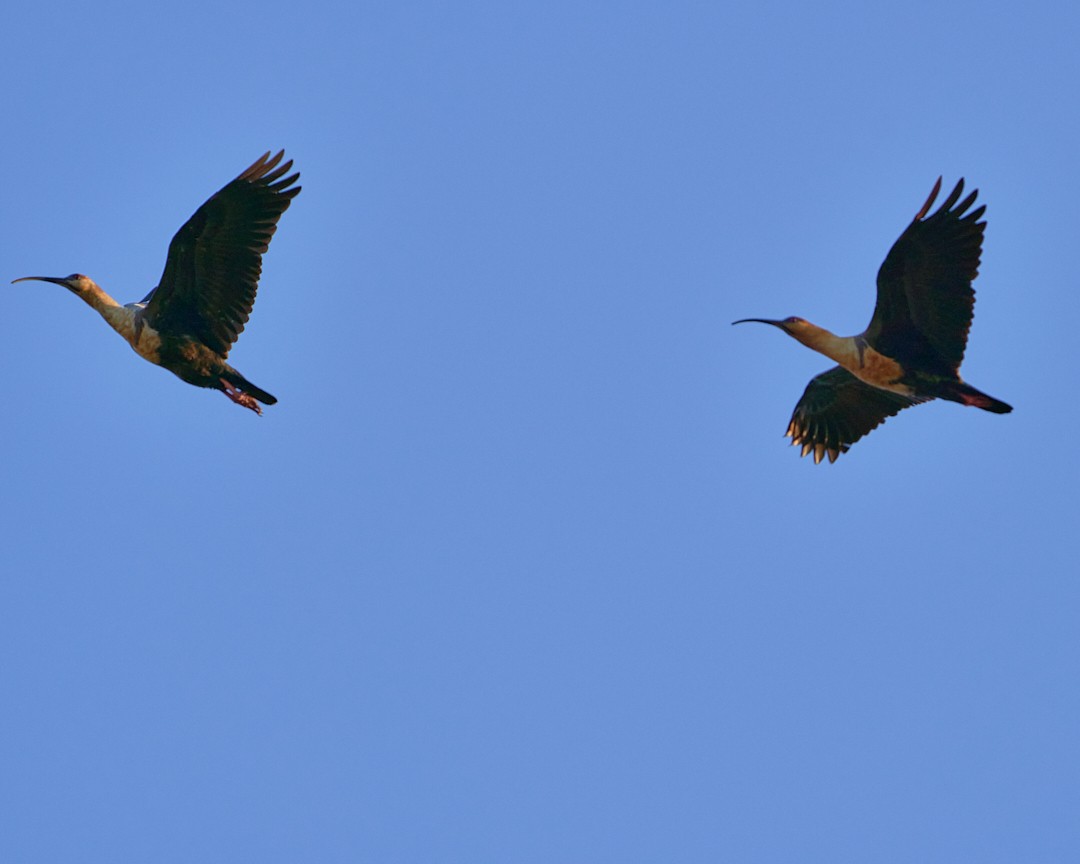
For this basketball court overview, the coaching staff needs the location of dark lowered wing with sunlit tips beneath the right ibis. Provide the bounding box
[785,366,926,463]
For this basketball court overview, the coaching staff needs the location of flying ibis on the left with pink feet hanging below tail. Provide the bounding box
[15,151,300,414]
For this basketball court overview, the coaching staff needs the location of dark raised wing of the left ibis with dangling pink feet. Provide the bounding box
[144,151,300,357]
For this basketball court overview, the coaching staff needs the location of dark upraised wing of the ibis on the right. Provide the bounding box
[866,177,986,374]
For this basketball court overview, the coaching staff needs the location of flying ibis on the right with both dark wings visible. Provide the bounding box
[733,177,1012,463]
